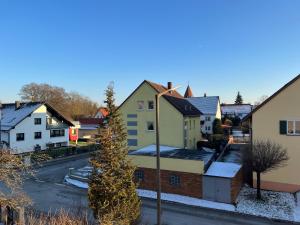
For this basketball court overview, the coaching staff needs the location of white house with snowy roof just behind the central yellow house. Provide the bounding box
[186,95,222,134]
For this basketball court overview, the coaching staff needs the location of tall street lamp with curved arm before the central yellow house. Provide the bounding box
[155,86,180,225]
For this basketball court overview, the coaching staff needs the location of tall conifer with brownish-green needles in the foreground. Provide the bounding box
[88,85,140,225]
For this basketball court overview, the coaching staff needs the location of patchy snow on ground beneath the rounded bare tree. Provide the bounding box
[236,187,296,221]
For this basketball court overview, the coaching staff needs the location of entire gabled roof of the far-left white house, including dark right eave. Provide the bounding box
[1,102,73,131]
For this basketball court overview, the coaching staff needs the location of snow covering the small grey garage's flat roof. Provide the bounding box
[205,162,242,178]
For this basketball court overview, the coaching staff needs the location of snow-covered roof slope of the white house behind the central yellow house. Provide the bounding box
[186,96,219,115]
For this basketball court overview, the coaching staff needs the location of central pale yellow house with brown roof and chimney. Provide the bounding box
[119,80,202,150]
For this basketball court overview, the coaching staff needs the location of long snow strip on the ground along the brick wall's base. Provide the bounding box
[137,189,235,211]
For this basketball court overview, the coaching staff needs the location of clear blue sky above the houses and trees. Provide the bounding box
[0,0,300,103]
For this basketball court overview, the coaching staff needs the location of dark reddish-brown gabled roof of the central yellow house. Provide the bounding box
[119,80,202,116]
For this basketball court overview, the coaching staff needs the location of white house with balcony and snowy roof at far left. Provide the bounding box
[0,102,73,153]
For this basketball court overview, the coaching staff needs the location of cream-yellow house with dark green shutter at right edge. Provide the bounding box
[249,75,300,192]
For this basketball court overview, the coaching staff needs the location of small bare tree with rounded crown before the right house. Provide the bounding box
[251,140,289,199]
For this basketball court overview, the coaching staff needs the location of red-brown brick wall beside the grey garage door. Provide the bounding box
[137,168,202,198]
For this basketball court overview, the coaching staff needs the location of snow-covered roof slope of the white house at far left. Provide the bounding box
[1,102,42,131]
